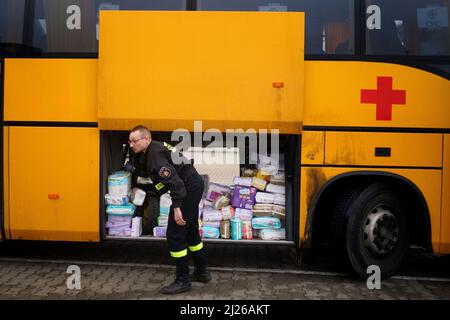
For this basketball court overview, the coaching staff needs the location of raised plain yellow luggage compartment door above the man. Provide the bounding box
[98,11,304,134]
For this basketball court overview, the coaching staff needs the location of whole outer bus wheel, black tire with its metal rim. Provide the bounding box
[346,183,410,279]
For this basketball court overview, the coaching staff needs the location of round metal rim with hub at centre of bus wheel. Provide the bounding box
[363,205,399,256]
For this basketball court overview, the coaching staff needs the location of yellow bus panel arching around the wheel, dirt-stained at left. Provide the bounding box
[299,167,442,252]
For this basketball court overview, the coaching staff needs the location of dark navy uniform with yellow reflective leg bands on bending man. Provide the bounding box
[133,140,206,292]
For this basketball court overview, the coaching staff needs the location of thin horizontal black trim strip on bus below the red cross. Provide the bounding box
[303,126,450,133]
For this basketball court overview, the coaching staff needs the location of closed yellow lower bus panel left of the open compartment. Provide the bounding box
[9,127,100,241]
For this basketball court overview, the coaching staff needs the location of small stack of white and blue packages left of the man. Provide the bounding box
[105,171,136,237]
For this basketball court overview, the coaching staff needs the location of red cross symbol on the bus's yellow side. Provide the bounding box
[361,77,406,121]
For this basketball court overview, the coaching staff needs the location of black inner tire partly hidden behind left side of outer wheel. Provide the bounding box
[330,185,364,268]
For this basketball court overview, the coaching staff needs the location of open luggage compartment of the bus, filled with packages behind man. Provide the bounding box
[100,130,300,244]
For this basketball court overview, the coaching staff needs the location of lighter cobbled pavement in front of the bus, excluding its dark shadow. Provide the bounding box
[0,261,450,300]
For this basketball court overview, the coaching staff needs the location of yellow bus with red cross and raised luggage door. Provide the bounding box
[0,0,450,278]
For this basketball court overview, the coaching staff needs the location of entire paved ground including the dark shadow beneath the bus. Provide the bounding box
[0,241,450,301]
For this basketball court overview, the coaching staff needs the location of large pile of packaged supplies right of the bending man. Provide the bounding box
[201,157,286,240]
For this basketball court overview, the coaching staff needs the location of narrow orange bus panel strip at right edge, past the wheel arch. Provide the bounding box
[439,134,450,253]
